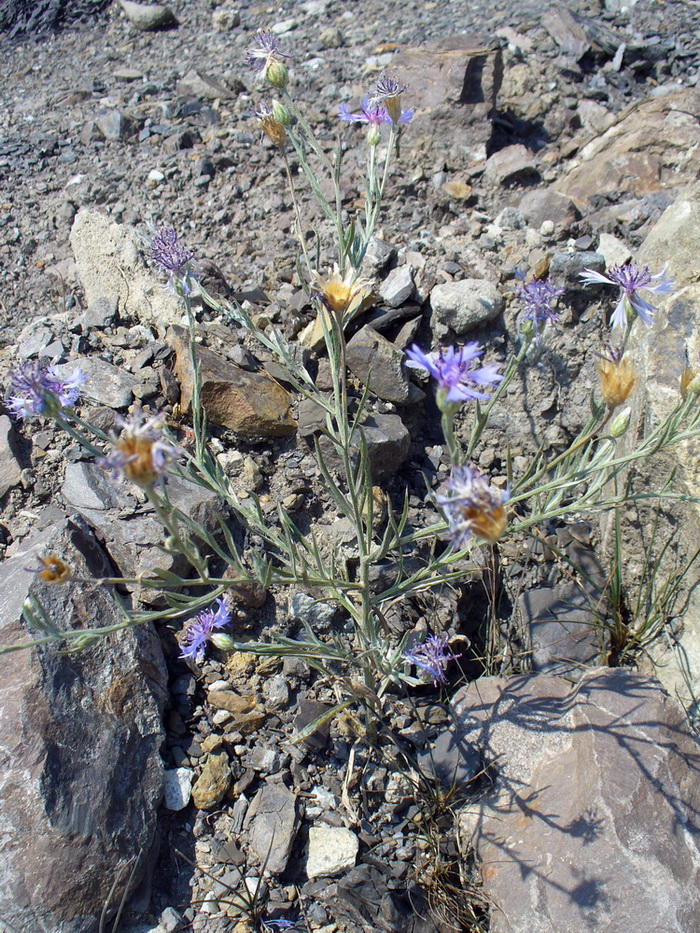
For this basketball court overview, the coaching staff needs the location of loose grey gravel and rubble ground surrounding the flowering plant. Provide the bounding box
[0,0,700,933]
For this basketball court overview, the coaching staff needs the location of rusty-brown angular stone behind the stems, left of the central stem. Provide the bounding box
[171,335,296,437]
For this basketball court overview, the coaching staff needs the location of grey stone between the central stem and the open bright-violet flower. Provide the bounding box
[346,326,410,404]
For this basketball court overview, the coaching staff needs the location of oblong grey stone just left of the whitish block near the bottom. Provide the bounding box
[248,784,298,875]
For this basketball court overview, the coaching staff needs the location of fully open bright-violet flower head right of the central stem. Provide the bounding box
[406,342,503,407]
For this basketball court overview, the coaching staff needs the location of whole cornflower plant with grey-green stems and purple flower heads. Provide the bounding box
[4,32,700,748]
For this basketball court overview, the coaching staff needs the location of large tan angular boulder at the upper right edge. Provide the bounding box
[554,88,700,210]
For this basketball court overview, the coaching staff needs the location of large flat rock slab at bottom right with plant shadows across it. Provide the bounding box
[454,668,700,933]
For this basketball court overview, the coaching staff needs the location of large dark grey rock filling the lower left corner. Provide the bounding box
[0,509,167,933]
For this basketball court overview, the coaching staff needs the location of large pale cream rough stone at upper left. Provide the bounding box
[70,210,182,335]
